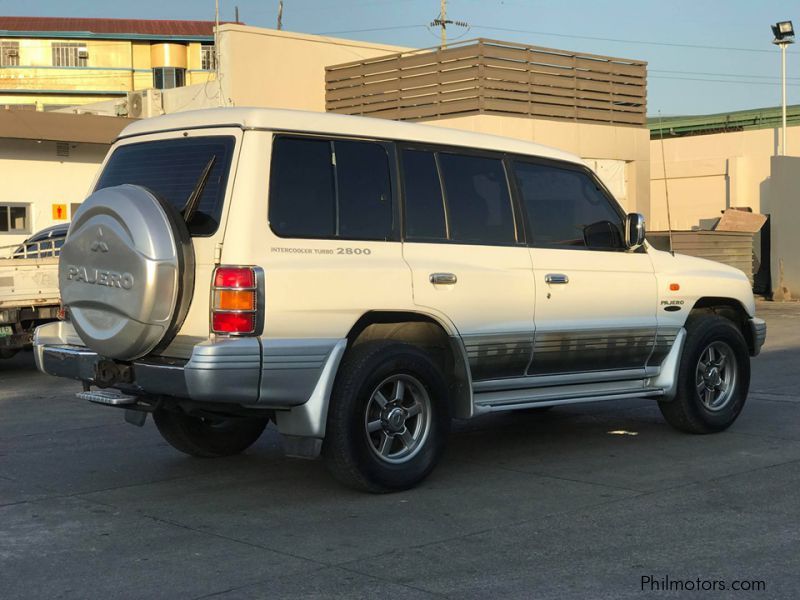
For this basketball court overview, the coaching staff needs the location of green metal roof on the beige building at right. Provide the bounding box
[647,104,800,139]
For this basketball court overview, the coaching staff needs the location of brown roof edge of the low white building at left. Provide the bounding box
[0,109,134,144]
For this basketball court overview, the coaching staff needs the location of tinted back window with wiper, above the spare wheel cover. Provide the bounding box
[95,136,236,236]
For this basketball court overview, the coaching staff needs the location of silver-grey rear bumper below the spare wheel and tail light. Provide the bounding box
[33,321,340,409]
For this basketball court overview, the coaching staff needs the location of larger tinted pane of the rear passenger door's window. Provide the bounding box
[438,153,516,244]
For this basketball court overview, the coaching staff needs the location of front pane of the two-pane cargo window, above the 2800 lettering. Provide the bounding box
[333,141,392,240]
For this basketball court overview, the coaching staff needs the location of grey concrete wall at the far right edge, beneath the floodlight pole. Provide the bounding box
[761,156,800,300]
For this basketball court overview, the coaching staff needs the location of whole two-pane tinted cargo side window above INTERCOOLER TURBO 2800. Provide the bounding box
[269,137,392,240]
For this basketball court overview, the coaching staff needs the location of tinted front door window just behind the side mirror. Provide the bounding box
[514,161,625,250]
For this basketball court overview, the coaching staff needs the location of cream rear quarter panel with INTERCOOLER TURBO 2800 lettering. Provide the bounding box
[222,131,414,340]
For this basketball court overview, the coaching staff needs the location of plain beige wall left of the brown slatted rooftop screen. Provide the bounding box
[219,25,408,111]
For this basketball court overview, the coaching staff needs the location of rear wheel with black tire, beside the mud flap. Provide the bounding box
[322,341,450,493]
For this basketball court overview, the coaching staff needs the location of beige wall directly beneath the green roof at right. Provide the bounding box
[650,127,800,230]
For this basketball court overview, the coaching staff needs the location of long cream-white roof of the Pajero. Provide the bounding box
[120,108,584,164]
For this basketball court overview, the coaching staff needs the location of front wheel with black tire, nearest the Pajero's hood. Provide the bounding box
[658,315,750,433]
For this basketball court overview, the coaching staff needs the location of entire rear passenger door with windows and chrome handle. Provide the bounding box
[400,146,534,380]
